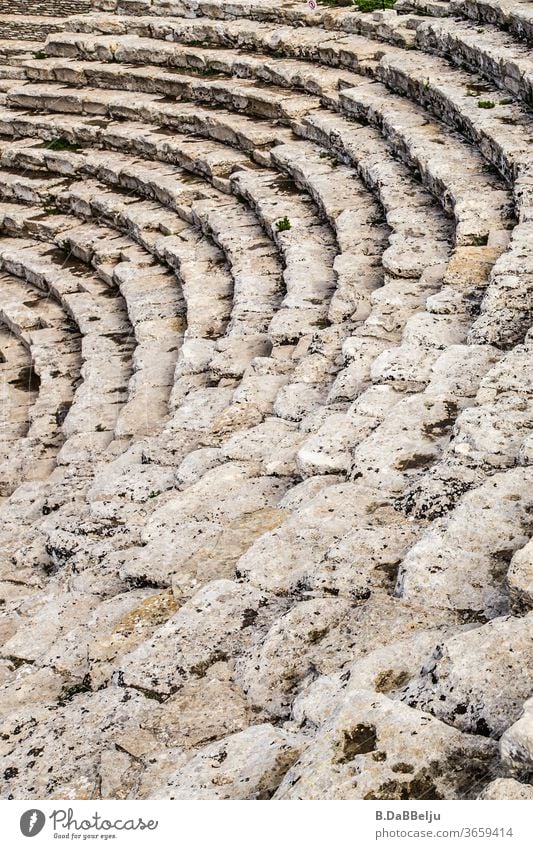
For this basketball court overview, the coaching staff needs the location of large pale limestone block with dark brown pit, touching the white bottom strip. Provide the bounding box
[274,690,496,800]
